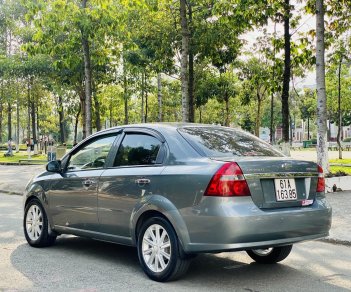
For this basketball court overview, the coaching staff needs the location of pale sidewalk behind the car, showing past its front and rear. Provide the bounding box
[0,165,351,246]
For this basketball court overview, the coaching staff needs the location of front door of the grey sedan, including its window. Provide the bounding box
[49,134,117,231]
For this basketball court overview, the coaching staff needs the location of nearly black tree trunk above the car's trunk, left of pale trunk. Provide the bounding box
[282,0,291,148]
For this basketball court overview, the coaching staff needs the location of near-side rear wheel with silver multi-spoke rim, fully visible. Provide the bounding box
[137,217,190,282]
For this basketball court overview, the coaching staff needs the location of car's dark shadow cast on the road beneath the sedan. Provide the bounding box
[11,236,346,291]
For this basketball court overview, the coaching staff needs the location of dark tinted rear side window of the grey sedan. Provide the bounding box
[113,133,162,166]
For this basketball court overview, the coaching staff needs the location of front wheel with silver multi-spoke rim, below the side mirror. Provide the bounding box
[23,199,56,247]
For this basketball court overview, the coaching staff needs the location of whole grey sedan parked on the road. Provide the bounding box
[23,124,332,281]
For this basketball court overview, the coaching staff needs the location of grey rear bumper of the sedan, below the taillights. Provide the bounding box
[181,197,332,253]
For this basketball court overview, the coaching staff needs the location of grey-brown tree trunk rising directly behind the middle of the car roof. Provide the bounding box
[180,0,190,122]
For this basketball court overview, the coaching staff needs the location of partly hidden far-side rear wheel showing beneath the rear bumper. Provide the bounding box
[246,245,292,264]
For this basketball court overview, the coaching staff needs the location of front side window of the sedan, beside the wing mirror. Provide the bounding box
[67,135,116,171]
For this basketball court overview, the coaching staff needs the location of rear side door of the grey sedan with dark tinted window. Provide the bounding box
[98,129,166,237]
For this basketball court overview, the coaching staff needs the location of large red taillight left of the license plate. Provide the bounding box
[205,162,251,197]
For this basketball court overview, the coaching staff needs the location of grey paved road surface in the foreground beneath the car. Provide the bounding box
[0,194,351,292]
